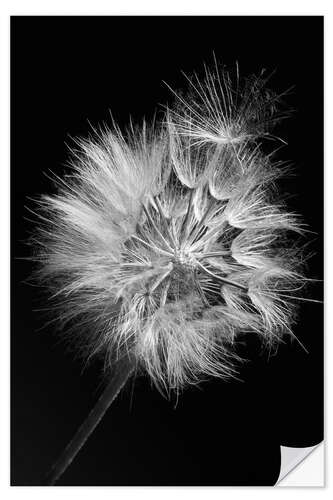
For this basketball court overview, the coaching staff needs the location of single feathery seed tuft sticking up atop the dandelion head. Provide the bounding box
[165,57,288,146]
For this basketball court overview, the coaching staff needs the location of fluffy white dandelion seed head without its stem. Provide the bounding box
[32,68,303,392]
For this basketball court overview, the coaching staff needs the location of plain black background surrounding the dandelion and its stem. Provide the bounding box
[11,17,323,485]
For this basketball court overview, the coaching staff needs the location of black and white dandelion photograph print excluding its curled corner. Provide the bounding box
[10,15,324,488]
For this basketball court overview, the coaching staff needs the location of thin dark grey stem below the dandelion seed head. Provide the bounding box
[42,356,134,486]
